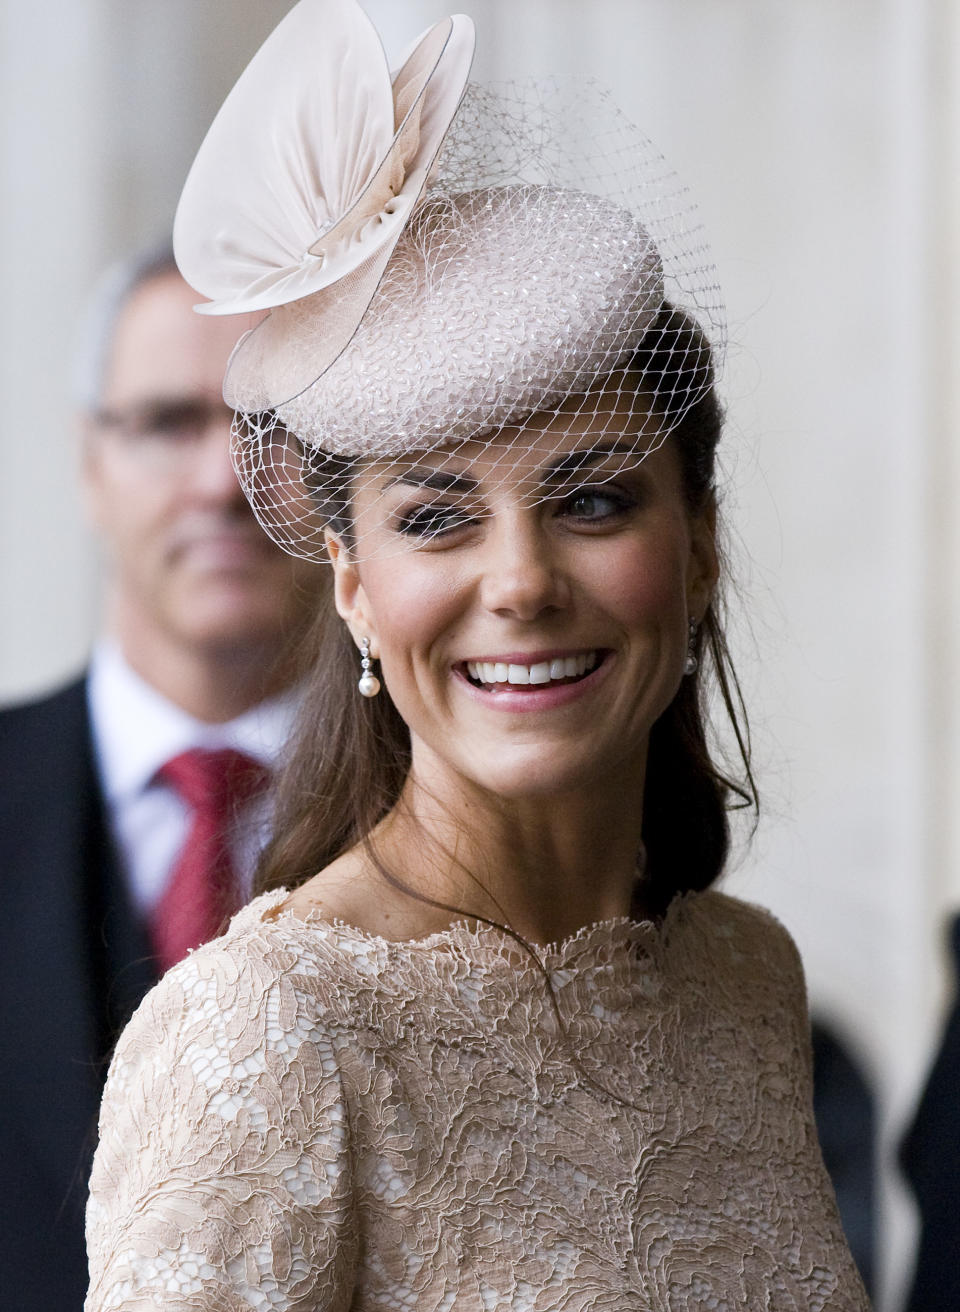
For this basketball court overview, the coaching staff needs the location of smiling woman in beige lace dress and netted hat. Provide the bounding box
[88,0,866,1312]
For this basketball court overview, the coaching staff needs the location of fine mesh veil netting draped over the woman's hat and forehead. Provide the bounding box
[235,81,724,558]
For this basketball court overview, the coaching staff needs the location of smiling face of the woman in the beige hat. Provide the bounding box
[332,398,717,798]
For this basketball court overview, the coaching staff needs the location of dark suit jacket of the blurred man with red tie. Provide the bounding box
[0,680,155,1312]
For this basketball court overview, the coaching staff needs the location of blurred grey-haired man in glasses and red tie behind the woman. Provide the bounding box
[0,251,323,1312]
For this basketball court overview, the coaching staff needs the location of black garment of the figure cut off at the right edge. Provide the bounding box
[901,916,960,1312]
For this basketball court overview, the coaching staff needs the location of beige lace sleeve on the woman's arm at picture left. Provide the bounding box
[85,945,357,1312]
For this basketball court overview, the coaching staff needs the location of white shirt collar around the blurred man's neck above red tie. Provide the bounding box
[87,640,299,803]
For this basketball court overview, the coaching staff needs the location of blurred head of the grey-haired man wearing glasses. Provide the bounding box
[84,272,315,657]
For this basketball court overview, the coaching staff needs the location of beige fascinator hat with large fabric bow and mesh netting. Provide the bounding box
[174,0,724,556]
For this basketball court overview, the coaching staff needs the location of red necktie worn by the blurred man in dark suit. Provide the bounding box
[150,748,268,971]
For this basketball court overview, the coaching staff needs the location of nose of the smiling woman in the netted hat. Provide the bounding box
[480,514,569,621]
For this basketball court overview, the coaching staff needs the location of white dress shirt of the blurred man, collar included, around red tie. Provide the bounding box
[87,642,298,916]
